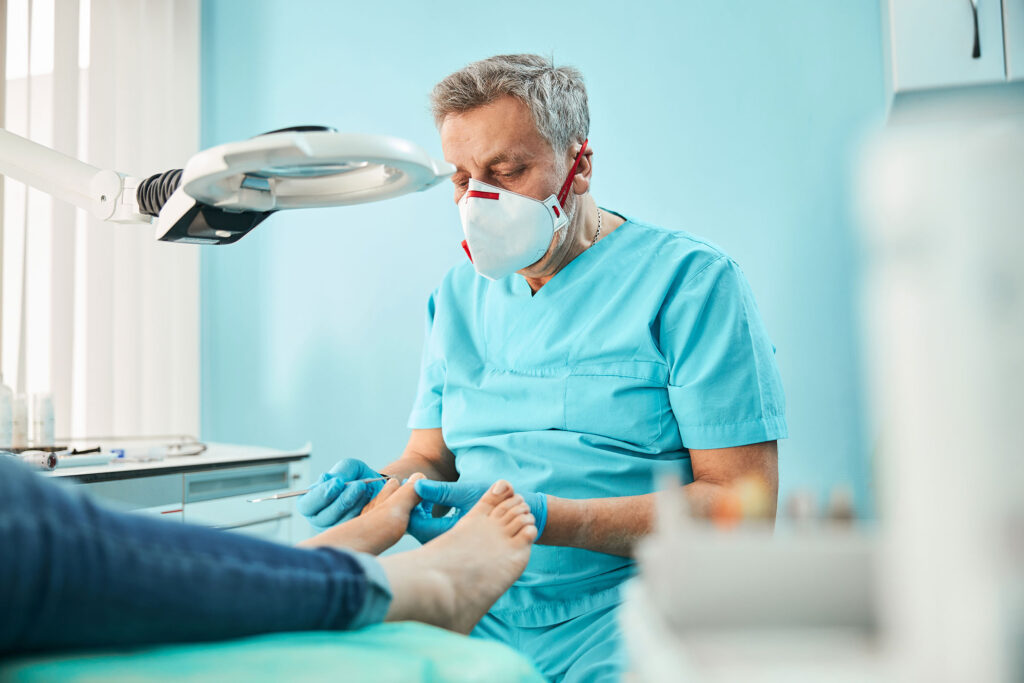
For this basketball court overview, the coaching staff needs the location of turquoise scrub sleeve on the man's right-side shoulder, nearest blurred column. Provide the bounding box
[658,256,788,449]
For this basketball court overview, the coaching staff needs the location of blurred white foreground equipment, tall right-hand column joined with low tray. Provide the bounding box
[622,88,1024,683]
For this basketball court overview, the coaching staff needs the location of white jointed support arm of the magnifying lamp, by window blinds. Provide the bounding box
[0,128,153,223]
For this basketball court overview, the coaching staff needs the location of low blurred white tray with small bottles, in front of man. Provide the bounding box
[620,481,886,683]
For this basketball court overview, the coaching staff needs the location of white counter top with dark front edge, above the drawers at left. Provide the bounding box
[43,443,312,483]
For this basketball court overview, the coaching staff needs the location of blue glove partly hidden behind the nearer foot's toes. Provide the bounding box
[409,479,548,543]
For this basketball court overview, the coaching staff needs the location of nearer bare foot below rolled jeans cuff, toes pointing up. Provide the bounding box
[381,481,537,634]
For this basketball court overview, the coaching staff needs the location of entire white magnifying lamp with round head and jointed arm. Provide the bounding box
[0,126,455,245]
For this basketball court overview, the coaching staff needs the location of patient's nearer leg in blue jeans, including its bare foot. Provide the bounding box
[0,456,537,655]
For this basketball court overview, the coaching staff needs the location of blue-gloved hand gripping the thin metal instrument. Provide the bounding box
[296,458,385,528]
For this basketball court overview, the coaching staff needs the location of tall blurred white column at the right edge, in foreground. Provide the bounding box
[861,86,1024,681]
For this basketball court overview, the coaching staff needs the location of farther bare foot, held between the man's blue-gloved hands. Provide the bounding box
[298,473,424,555]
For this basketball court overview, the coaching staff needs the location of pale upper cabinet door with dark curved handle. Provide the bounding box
[883,0,1014,92]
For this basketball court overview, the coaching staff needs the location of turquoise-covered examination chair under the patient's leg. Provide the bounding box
[0,623,544,683]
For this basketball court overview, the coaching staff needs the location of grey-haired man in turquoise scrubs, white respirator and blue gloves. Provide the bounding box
[300,55,786,681]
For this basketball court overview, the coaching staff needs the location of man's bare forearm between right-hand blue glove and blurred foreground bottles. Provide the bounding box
[537,481,770,557]
